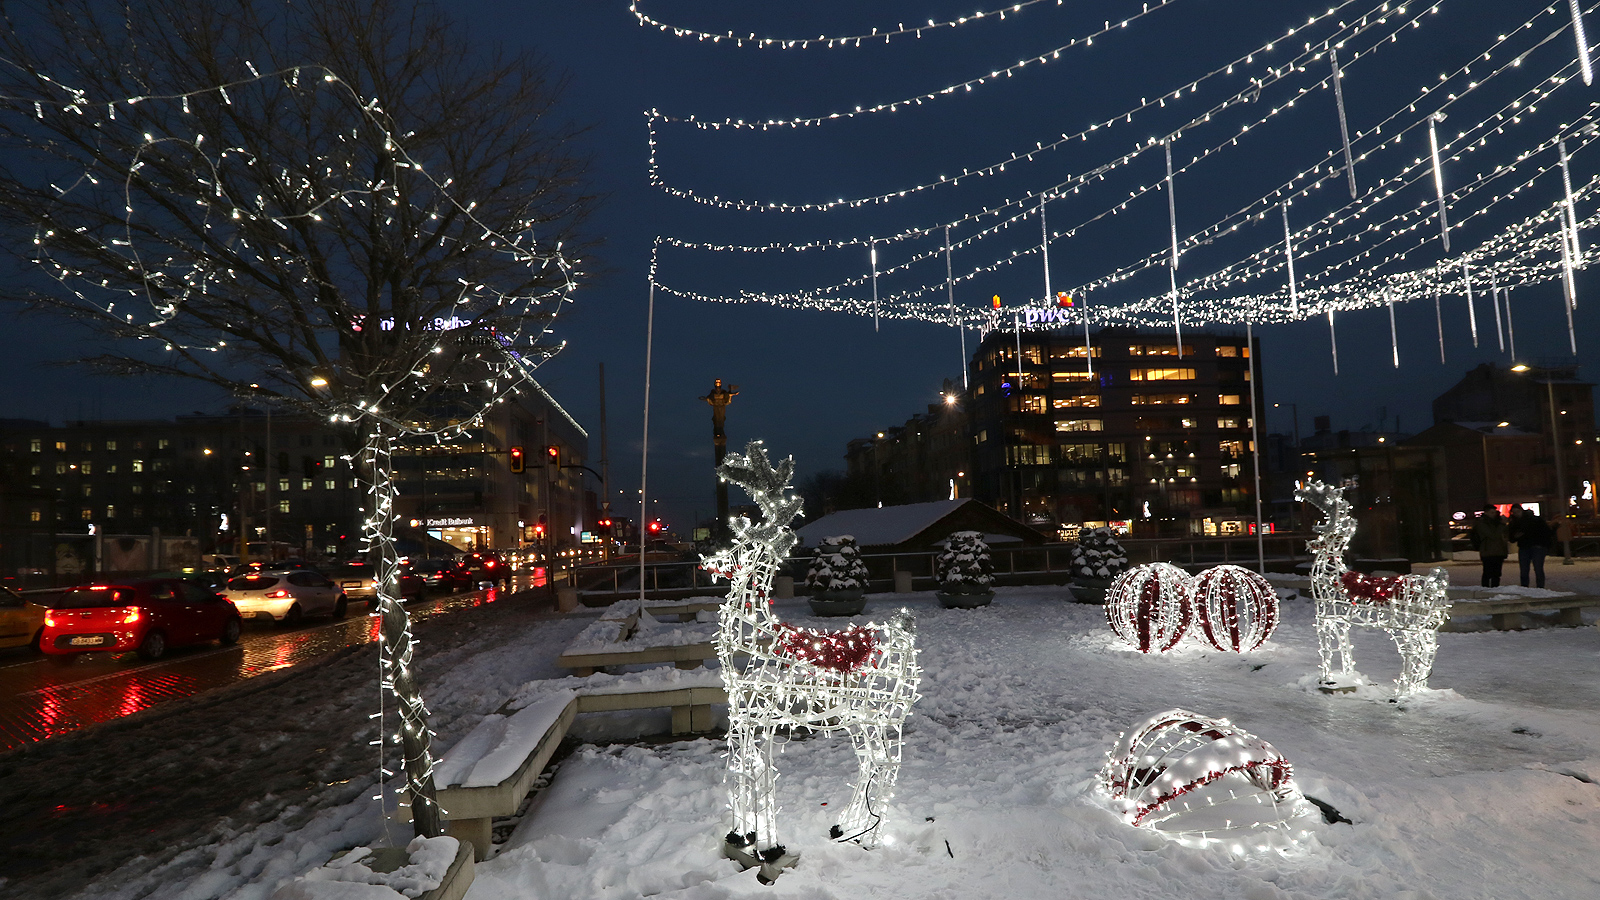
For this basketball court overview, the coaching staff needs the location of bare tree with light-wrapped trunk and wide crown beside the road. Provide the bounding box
[0,0,589,836]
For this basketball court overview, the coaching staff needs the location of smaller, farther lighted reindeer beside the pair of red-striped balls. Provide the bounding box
[1294,480,1450,697]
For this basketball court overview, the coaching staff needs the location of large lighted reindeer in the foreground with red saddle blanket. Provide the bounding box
[704,440,922,884]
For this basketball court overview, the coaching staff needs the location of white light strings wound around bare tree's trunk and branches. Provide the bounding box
[0,57,592,836]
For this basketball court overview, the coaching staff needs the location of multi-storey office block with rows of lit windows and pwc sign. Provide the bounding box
[968,328,1266,538]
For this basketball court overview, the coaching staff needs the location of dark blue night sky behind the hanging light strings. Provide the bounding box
[0,0,1600,525]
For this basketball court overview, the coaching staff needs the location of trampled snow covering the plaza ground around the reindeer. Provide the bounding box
[18,559,1600,900]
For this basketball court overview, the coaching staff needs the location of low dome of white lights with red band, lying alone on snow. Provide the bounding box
[1099,709,1312,850]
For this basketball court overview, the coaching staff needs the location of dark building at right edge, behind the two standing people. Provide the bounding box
[1406,364,1600,519]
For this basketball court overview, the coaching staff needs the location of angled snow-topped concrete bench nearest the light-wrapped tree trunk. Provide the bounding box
[422,685,728,860]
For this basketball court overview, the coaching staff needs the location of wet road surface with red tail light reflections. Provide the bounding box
[0,580,542,753]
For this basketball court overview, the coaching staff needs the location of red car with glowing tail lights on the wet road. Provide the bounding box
[38,578,242,660]
